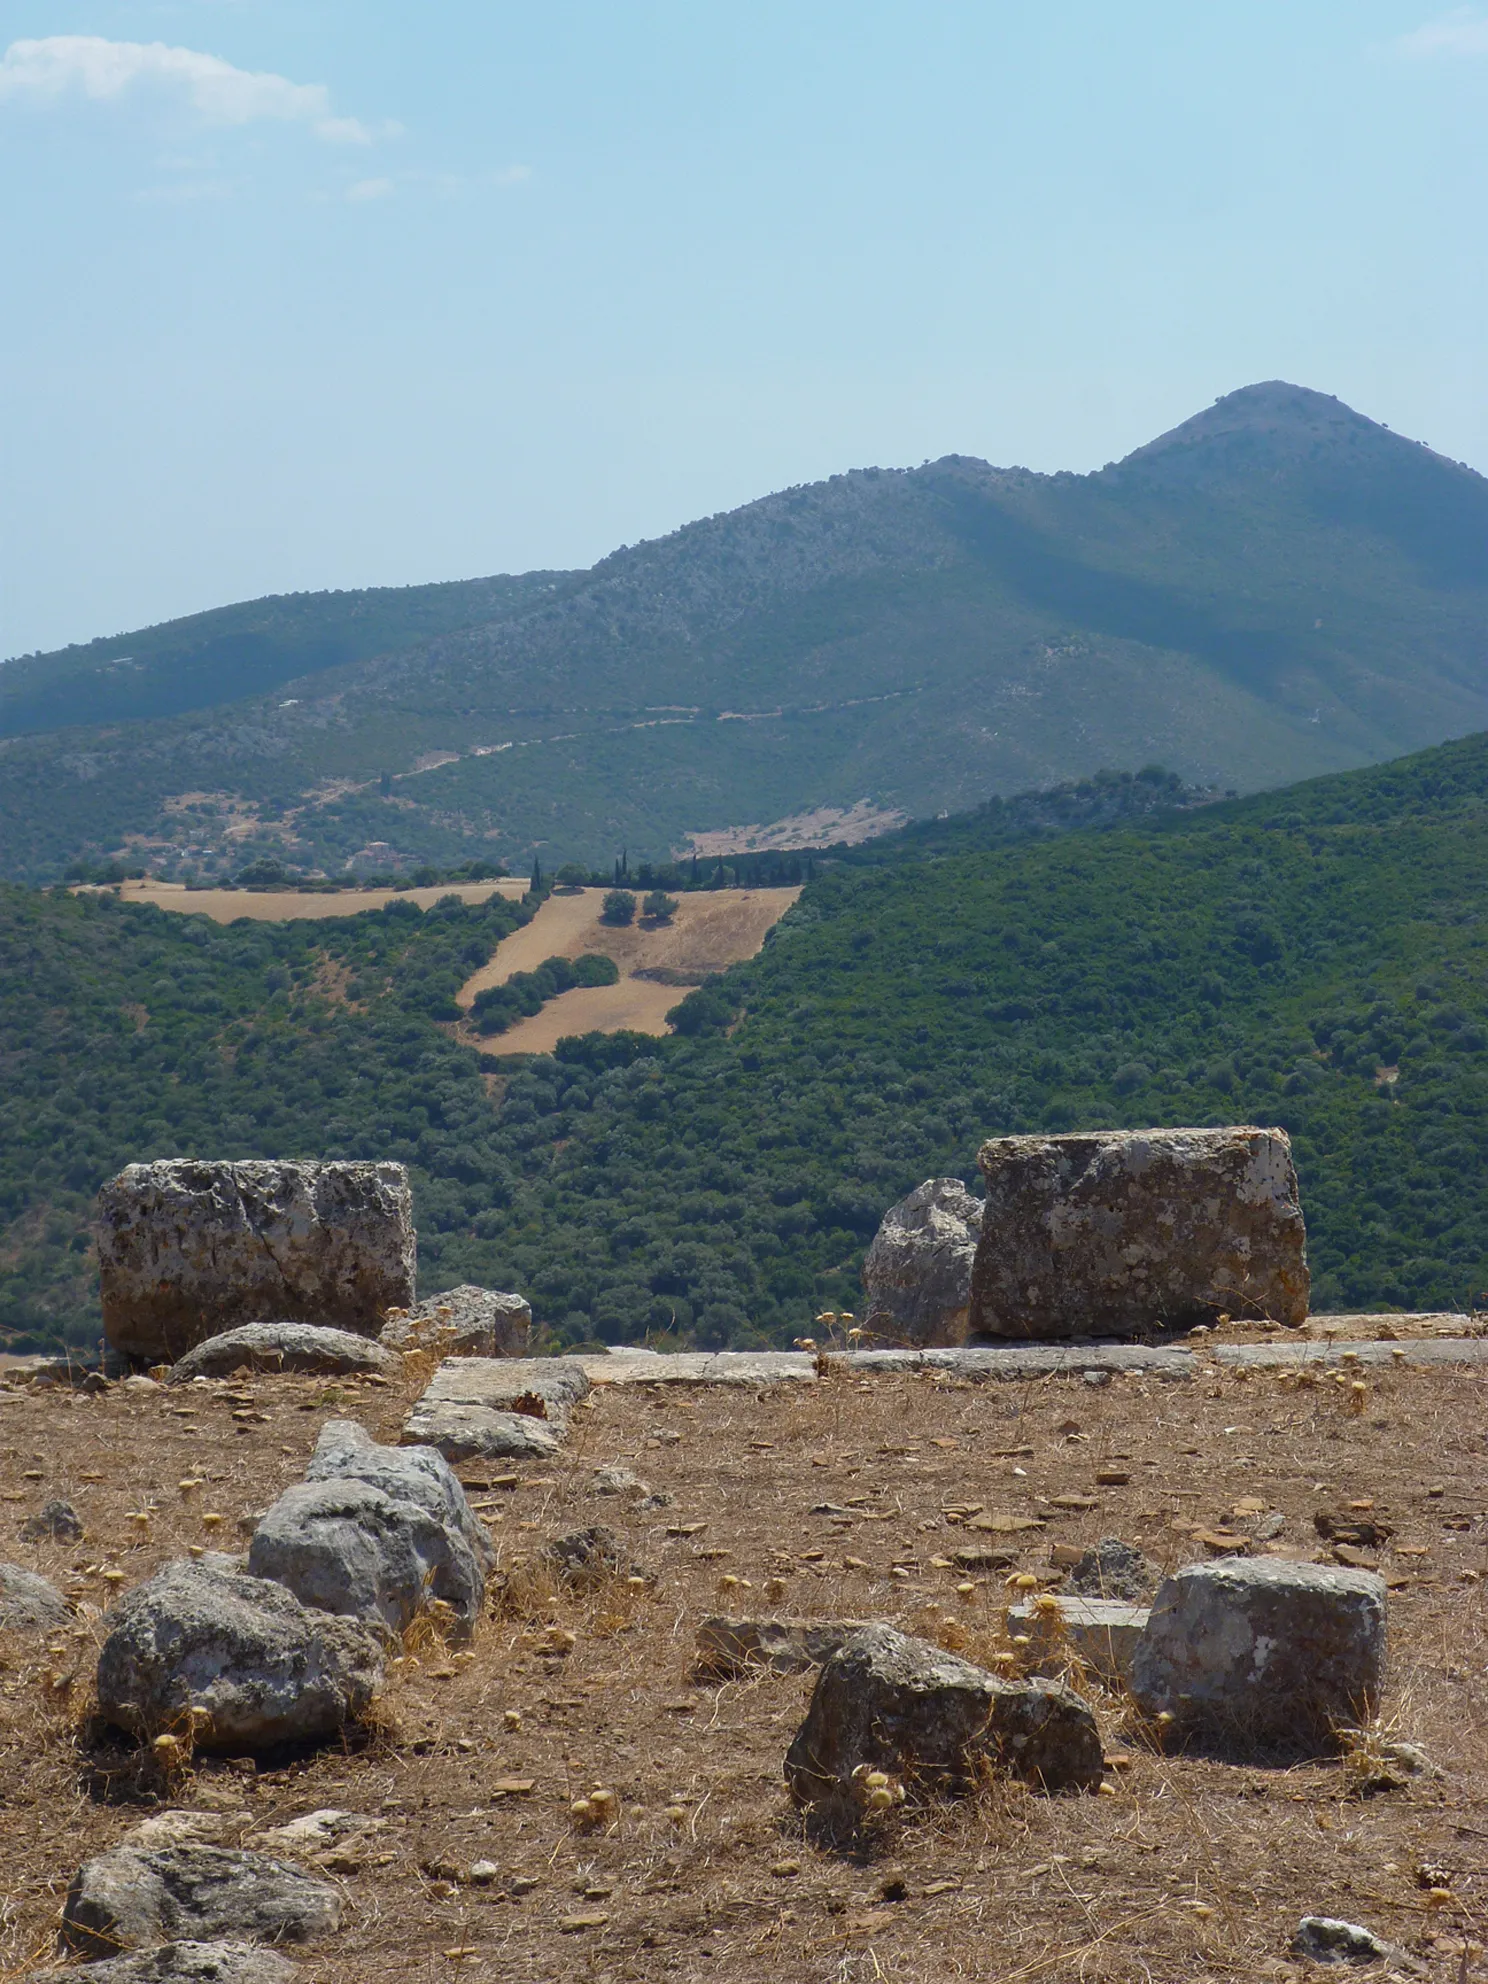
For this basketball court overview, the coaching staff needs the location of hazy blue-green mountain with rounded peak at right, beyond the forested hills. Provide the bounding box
[0,383,1488,881]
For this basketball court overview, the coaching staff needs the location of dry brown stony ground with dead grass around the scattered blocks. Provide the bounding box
[0,1341,1488,1984]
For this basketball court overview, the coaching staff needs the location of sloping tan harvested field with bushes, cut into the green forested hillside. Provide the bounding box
[458,889,802,1054]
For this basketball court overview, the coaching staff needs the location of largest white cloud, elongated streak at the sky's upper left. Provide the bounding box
[0,34,384,145]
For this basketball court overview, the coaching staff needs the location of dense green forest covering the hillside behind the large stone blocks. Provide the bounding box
[0,736,1488,1343]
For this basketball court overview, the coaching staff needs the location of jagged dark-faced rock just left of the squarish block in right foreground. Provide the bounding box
[786,1625,1105,1807]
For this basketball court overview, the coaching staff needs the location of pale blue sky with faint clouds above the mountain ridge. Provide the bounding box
[0,0,1488,655]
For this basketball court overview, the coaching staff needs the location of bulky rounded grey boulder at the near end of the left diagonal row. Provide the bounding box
[97,1559,383,1752]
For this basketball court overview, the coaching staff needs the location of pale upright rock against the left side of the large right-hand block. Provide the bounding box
[863,1178,982,1347]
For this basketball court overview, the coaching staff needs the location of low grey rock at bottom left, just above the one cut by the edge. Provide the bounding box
[62,1845,341,1974]
